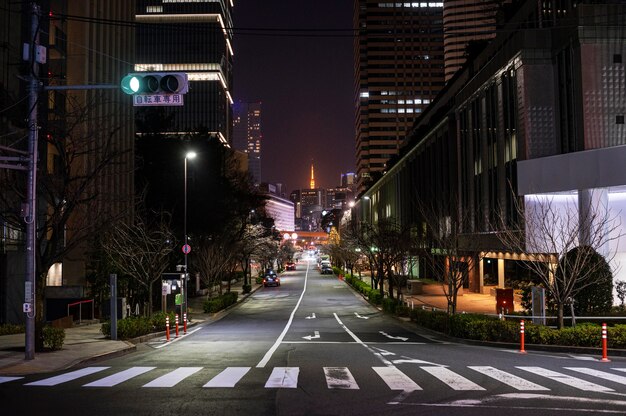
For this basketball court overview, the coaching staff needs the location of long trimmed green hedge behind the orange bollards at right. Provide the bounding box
[409,309,626,348]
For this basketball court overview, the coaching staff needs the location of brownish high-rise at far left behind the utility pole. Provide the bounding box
[0,0,134,323]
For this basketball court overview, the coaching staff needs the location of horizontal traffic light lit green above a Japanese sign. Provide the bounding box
[121,72,189,95]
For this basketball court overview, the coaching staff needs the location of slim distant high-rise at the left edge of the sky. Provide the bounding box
[233,101,263,184]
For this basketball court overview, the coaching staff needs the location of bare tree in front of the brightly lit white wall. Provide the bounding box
[498,193,621,328]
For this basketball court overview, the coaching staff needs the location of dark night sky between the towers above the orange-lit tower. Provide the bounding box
[233,0,355,195]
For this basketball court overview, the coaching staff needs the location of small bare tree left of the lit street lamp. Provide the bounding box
[103,214,176,315]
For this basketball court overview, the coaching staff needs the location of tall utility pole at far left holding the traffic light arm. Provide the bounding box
[24,2,41,360]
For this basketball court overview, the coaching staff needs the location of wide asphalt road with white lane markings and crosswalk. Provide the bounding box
[0,263,626,416]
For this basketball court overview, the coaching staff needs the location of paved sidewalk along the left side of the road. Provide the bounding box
[0,282,260,376]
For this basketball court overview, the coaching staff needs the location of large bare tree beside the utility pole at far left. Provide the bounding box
[0,94,133,342]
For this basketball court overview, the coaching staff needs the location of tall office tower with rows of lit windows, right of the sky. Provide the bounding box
[354,0,444,191]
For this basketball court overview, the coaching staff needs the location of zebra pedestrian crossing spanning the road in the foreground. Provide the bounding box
[0,365,626,393]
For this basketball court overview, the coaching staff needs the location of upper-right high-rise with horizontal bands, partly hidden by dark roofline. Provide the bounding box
[443,0,504,82]
